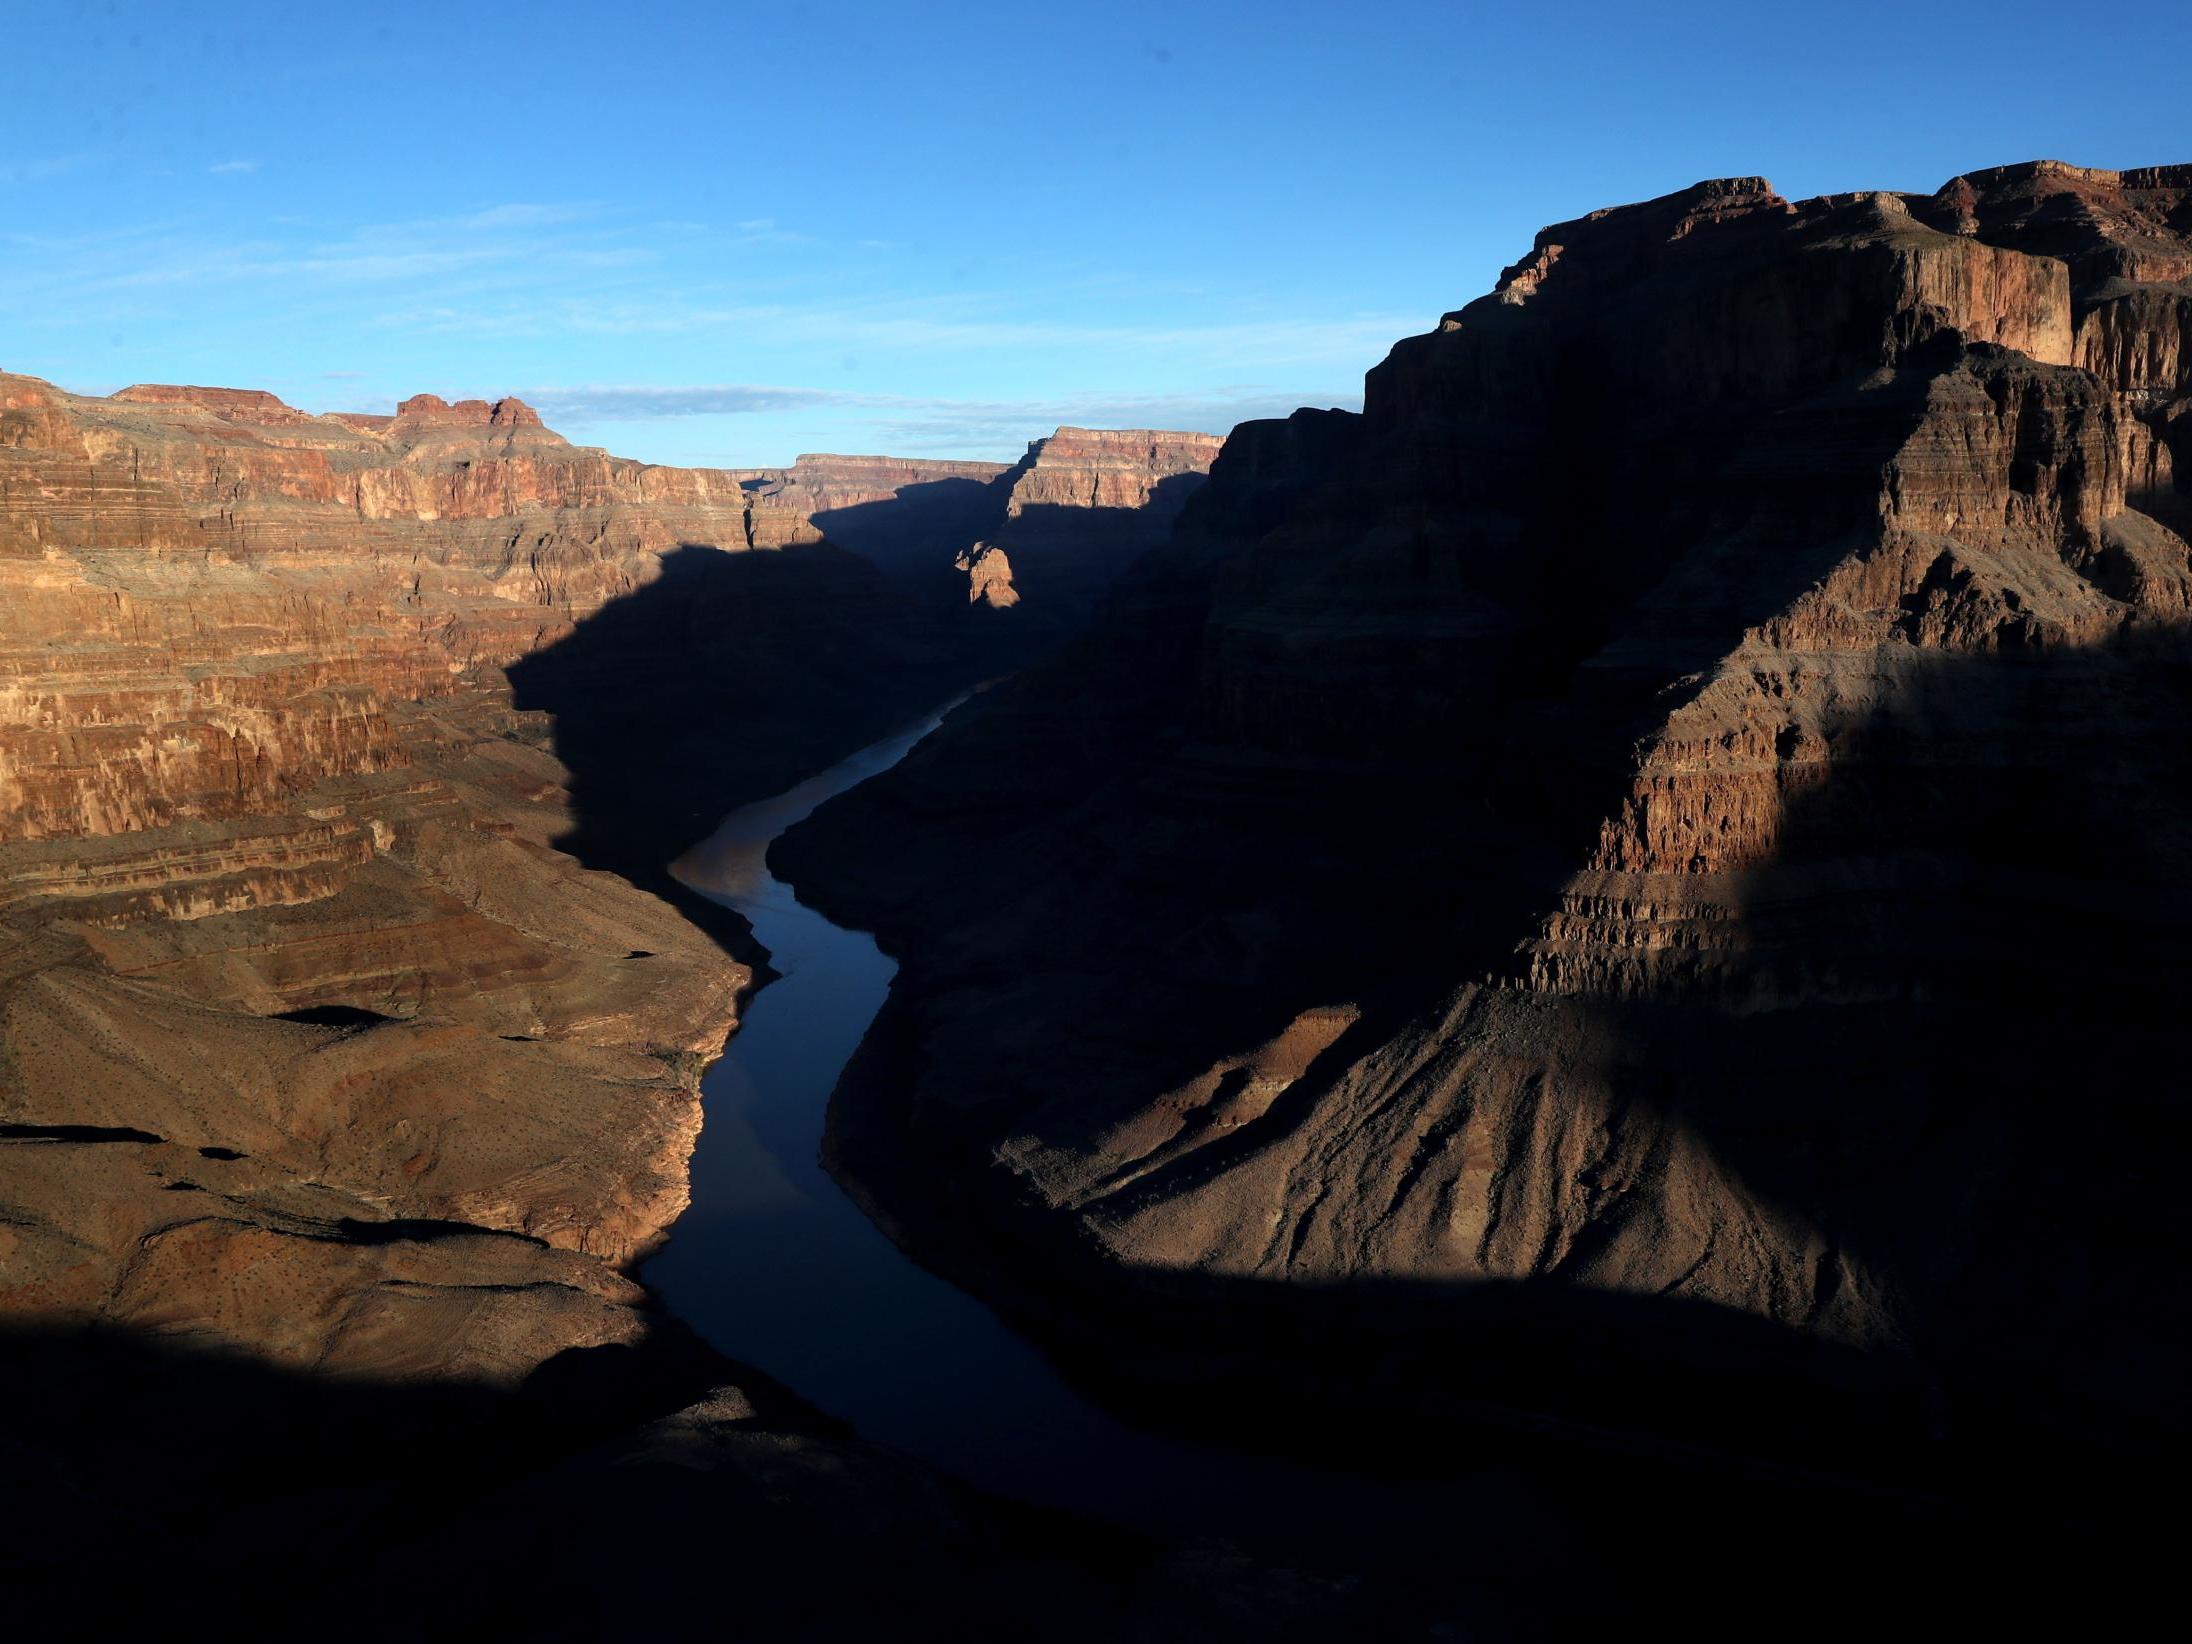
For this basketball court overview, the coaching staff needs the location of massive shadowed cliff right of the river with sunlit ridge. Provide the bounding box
[778,164,2192,1445]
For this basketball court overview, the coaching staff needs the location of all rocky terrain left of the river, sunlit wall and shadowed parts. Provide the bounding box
[0,377,1280,1624]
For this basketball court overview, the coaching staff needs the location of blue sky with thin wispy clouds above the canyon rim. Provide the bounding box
[0,0,2192,465]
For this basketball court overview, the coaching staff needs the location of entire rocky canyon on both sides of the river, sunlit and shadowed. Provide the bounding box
[0,162,2192,1635]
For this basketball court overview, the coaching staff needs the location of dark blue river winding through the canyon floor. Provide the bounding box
[644,710,1451,1534]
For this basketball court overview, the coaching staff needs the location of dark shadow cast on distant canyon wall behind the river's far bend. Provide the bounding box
[506,473,1227,964]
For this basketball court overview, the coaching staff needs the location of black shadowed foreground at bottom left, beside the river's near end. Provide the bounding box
[0,1331,1335,1640]
